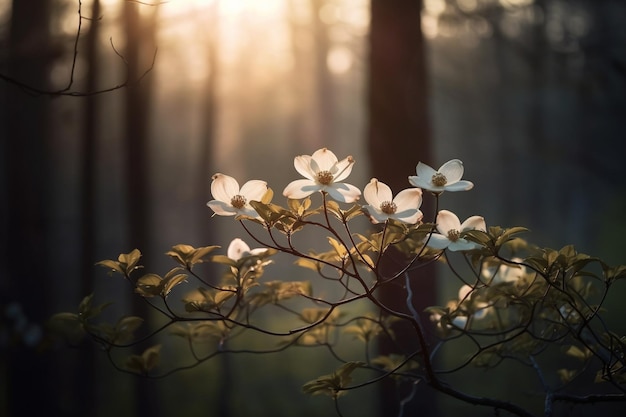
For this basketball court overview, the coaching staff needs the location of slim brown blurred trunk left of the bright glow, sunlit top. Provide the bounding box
[123,2,160,417]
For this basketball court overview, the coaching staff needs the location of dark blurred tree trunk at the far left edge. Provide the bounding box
[0,0,53,417]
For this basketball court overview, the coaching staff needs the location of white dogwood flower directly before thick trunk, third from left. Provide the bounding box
[363,178,423,224]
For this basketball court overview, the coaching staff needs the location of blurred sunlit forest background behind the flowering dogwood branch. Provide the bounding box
[0,0,626,417]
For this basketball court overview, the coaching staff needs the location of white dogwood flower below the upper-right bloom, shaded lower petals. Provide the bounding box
[428,210,487,252]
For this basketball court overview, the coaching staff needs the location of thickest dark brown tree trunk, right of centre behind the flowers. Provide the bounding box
[368,0,435,416]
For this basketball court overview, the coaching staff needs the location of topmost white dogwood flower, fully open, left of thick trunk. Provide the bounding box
[283,148,361,203]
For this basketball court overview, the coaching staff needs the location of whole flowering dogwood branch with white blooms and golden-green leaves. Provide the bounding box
[47,148,626,417]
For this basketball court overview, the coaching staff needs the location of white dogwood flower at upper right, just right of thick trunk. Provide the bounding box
[409,159,474,194]
